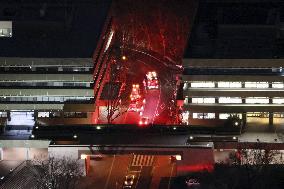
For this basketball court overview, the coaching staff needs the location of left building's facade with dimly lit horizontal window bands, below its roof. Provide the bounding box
[0,57,94,126]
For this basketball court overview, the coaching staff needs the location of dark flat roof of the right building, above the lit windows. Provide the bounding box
[184,0,284,58]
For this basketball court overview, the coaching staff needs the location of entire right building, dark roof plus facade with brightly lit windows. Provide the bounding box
[182,0,284,126]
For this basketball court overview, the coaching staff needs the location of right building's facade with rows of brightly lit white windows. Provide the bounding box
[182,59,284,125]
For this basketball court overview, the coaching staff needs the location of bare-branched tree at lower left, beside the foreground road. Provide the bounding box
[29,157,83,189]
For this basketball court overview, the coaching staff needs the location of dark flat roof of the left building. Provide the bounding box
[0,0,110,57]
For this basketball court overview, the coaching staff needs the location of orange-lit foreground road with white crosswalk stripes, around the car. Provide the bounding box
[77,154,176,189]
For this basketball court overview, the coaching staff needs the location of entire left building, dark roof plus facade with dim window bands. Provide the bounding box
[0,0,110,129]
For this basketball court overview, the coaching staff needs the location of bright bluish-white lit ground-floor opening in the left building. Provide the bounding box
[7,110,35,127]
